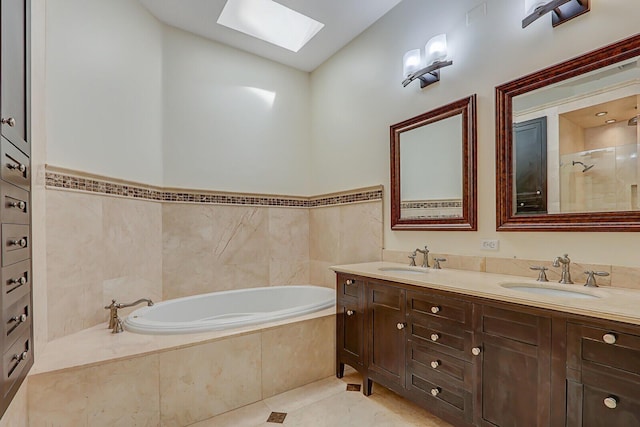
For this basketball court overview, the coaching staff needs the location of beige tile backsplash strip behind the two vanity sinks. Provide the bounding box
[382,249,640,290]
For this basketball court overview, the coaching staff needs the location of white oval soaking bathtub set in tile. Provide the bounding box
[124,285,335,334]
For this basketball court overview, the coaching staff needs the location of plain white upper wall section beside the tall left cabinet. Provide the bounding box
[46,0,162,185]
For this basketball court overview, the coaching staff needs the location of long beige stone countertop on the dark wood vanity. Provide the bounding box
[331,262,640,325]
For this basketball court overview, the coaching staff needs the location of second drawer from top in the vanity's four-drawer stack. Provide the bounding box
[407,315,472,360]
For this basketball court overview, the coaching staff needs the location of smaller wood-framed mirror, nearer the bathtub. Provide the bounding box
[390,94,477,231]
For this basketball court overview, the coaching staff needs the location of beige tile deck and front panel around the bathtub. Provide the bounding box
[27,308,335,427]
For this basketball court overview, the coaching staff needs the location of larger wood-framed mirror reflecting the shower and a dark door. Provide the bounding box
[496,34,640,231]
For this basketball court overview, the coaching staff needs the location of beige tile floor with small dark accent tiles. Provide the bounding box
[190,370,451,427]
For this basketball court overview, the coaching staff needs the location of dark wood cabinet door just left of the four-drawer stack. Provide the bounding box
[367,283,406,390]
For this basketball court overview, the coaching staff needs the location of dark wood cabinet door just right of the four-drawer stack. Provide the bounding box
[476,306,551,427]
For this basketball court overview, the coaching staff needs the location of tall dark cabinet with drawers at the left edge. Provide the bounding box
[0,0,34,417]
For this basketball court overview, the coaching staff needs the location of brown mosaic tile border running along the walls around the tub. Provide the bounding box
[45,171,383,208]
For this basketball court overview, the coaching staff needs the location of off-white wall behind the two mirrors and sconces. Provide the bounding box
[311,0,640,267]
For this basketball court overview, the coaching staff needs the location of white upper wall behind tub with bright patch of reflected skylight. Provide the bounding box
[163,27,310,195]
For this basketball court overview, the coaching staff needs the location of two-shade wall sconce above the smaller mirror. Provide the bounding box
[402,34,453,88]
